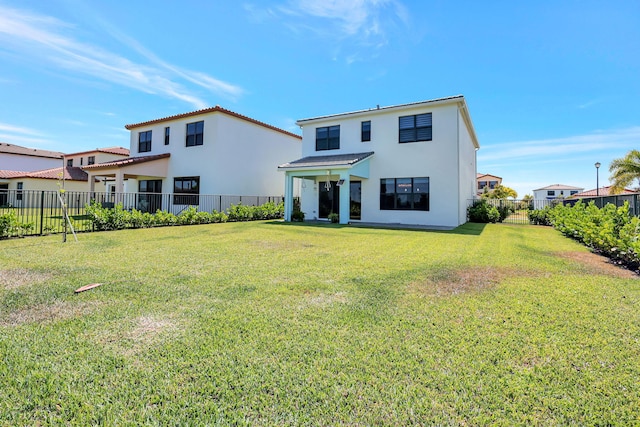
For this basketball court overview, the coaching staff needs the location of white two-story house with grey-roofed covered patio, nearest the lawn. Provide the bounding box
[278,95,480,228]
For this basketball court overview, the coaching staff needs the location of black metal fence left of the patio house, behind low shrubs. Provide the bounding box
[0,190,284,235]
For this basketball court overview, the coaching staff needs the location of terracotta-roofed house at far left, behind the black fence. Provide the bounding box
[0,147,129,207]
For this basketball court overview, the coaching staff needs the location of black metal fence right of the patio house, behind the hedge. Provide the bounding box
[468,193,640,224]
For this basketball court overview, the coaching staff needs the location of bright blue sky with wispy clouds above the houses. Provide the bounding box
[0,0,640,196]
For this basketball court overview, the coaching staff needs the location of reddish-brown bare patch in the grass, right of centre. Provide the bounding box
[409,267,521,296]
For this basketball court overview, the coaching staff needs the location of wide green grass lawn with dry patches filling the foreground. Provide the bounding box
[0,222,640,426]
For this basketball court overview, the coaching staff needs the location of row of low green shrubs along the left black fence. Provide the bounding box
[86,201,284,230]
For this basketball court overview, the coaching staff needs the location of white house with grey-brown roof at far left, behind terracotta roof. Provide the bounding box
[0,142,63,172]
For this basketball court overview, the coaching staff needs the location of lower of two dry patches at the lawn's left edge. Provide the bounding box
[0,301,100,326]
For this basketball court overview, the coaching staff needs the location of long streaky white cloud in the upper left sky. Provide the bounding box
[0,6,243,108]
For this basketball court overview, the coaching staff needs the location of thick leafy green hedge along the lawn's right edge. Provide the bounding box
[530,201,640,269]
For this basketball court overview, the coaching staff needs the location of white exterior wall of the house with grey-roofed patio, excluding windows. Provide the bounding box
[301,103,476,227]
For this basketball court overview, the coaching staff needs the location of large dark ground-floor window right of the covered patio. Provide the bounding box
[380,177,429,211]
